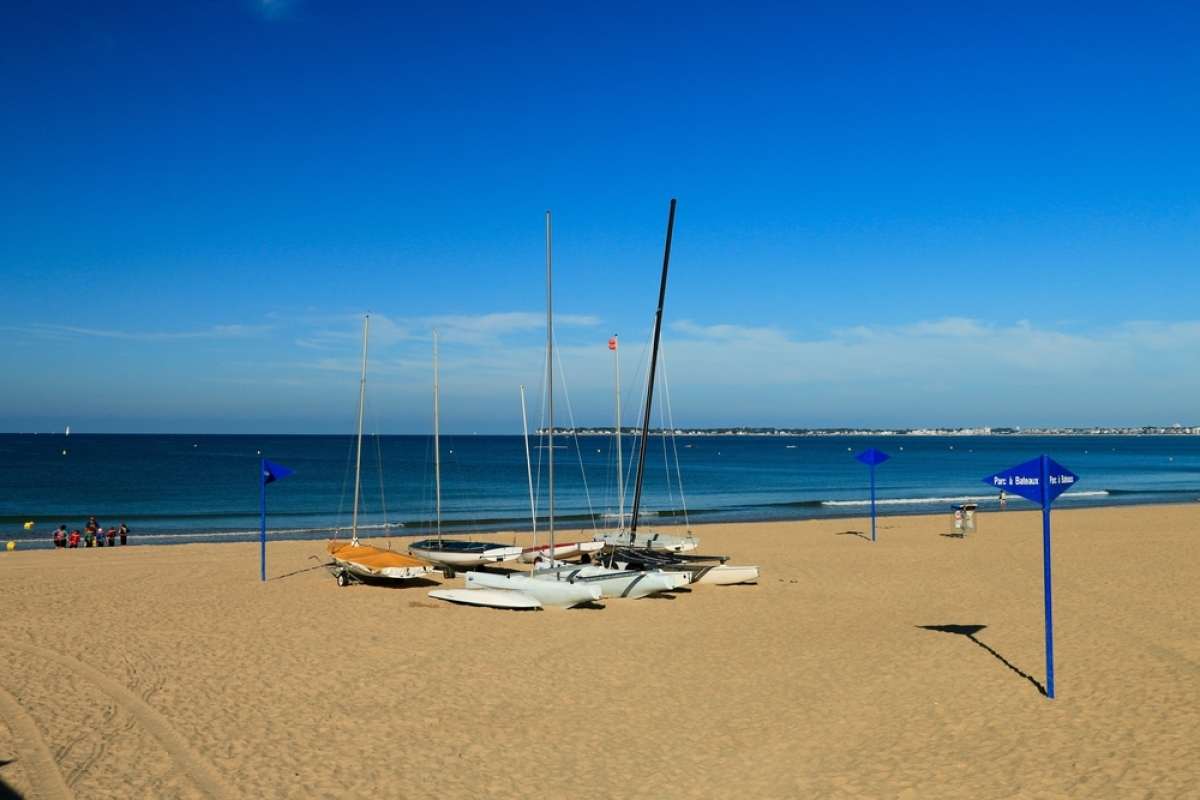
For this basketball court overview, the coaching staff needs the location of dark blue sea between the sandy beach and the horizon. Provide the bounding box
[0,433,1200,547]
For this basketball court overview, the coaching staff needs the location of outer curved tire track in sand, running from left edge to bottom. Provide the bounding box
[0,638,240,798]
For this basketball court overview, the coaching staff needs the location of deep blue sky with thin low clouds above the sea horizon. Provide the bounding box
[0,0,1200,433]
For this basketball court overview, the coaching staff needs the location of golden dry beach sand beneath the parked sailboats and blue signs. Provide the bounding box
[0,506,1200,799]
